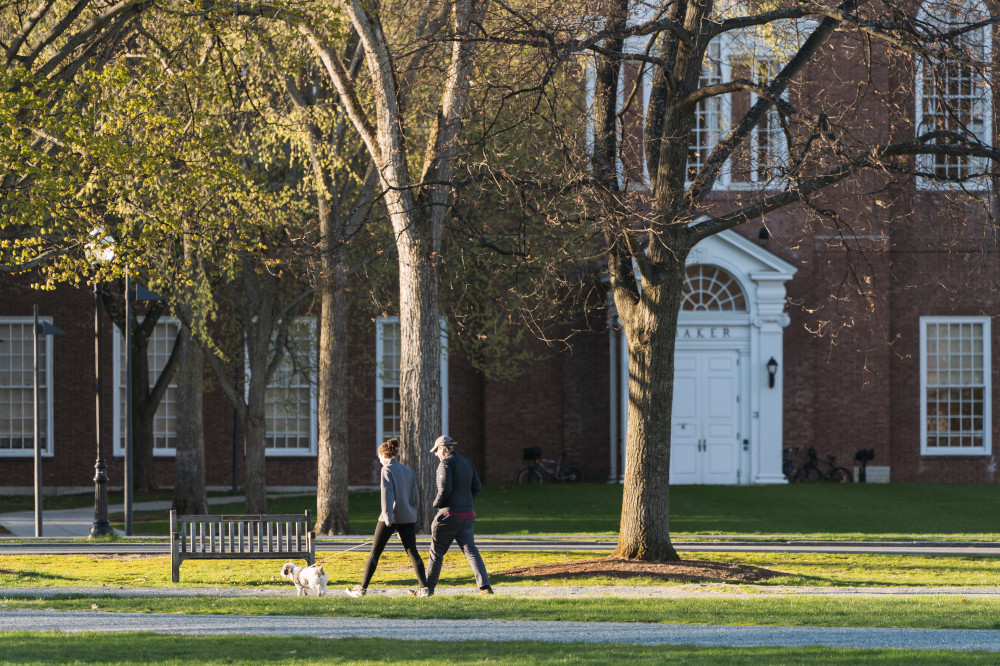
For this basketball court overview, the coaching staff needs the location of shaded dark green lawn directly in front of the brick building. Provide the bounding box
[88,483,1000,540]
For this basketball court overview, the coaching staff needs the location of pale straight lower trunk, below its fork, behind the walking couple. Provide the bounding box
[399,234,442,530]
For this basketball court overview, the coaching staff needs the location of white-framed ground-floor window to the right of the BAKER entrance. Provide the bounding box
[920,317,992,455]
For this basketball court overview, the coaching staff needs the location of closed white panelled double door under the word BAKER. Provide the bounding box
[670,351,740,484]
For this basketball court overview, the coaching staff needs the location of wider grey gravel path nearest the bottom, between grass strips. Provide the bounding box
[0,610,1000,652]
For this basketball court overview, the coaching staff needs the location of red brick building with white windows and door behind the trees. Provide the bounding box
[0,1,998,492]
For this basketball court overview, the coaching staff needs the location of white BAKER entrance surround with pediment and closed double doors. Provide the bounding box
[609,231,796,484]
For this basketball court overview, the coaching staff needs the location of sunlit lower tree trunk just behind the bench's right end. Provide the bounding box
[316,246,355,534]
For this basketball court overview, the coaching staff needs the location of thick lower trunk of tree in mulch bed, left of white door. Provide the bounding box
[615,252,687,562]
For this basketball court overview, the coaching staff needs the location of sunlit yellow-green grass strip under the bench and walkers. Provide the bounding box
[0,539,1000,588]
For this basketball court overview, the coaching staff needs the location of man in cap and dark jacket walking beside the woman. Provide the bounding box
[420,435,493,596]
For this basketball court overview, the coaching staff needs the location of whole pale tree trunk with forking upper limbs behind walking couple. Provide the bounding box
[308,0,486,528]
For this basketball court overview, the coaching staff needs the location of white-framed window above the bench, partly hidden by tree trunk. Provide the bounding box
[265,317,319,456]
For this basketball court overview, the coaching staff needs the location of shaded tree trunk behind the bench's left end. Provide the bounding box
[173,328,209,515]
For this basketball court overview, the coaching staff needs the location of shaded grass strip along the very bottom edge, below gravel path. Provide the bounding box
[0,633,996,666]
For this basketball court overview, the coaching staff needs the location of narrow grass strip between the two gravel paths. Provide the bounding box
[0,588,1000,630]
